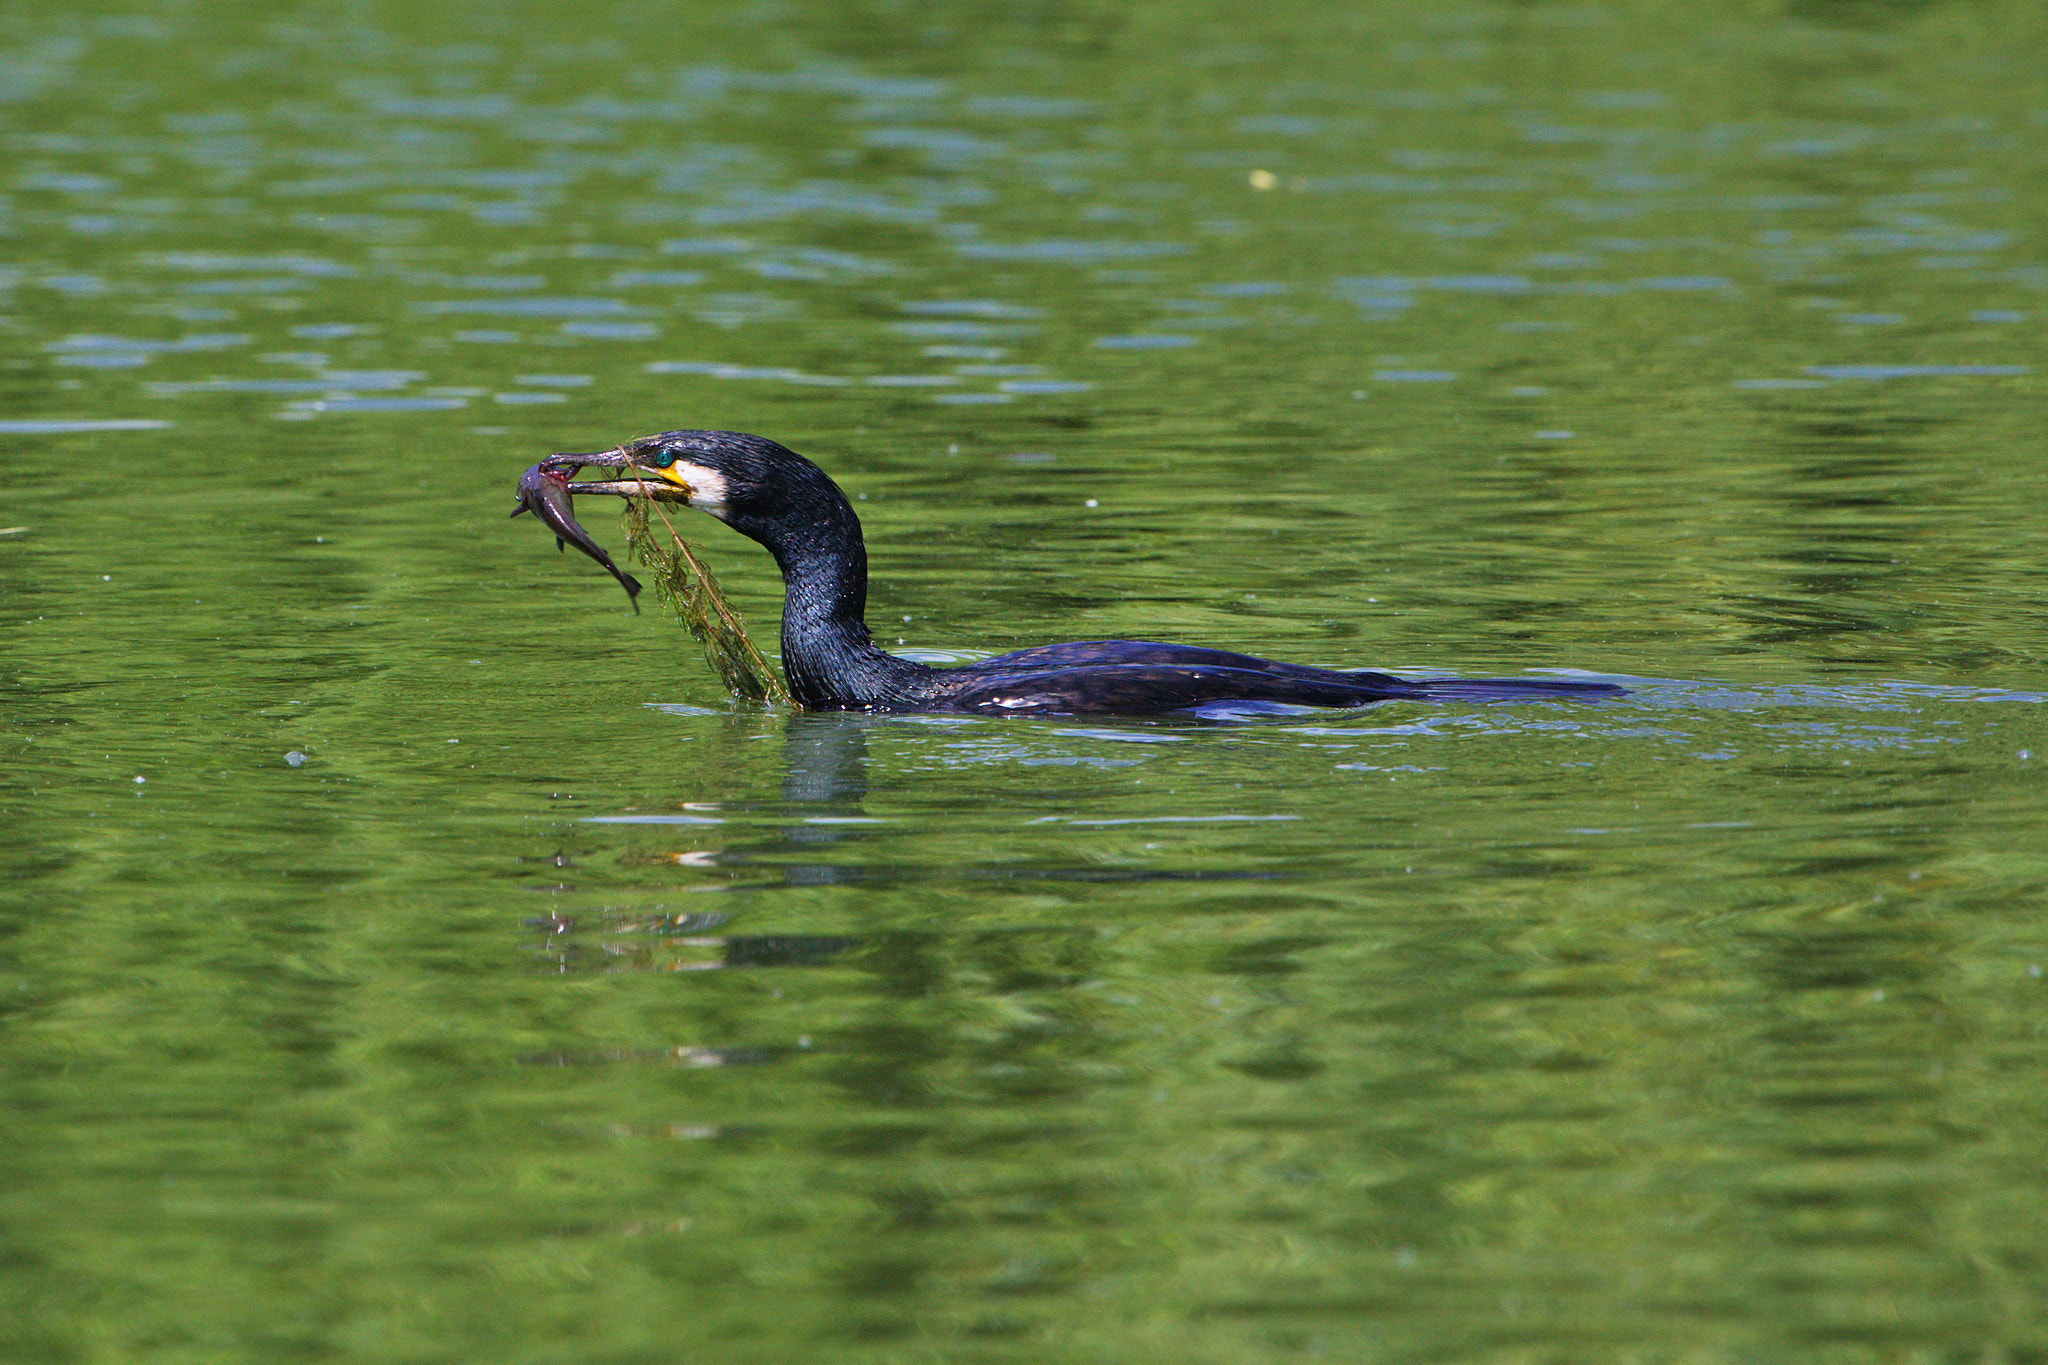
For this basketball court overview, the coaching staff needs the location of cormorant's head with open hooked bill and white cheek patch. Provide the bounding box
[549,432,852,544]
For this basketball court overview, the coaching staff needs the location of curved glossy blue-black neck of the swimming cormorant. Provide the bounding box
[733,479,932,710]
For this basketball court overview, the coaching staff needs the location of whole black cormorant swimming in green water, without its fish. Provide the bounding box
[537,432,1622,716]
